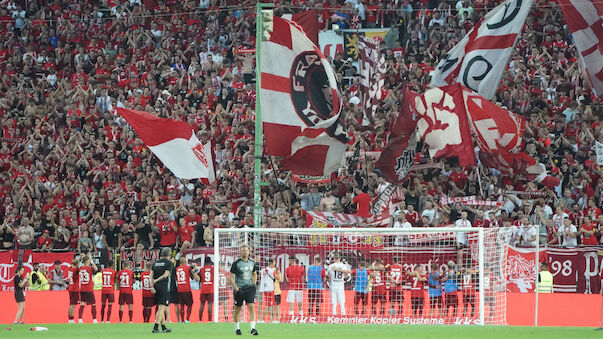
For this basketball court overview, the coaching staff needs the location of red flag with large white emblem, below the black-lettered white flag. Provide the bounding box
[415,84,477,167]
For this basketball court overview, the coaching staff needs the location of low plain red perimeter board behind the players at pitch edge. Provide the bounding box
[0,291,602,327]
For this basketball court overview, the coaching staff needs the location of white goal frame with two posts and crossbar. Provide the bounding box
[213,227,485,325]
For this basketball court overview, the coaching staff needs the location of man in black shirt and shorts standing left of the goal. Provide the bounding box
[152,247,174,333]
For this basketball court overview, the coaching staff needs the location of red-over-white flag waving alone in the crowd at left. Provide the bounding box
[116,107,215,183]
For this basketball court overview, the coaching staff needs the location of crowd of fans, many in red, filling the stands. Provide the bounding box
[0,0,603,260]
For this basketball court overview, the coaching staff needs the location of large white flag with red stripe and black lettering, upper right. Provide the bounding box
[430,0,534,99]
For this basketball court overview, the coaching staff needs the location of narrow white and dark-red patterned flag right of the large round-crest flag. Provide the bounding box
[357,35,387,126]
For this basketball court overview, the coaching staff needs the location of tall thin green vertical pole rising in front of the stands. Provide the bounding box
[253,2,273,227]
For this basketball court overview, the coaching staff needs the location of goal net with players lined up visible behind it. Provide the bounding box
[213,227,511,325]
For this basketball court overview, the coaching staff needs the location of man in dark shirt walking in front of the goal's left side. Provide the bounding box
[229,245,258,335]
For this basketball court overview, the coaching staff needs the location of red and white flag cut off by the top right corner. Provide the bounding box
[557,0,603,97]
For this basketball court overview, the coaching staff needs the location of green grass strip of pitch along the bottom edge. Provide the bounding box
[0,323,603,339]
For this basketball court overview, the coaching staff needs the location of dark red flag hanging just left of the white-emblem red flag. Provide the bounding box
[375,86,417,183]
